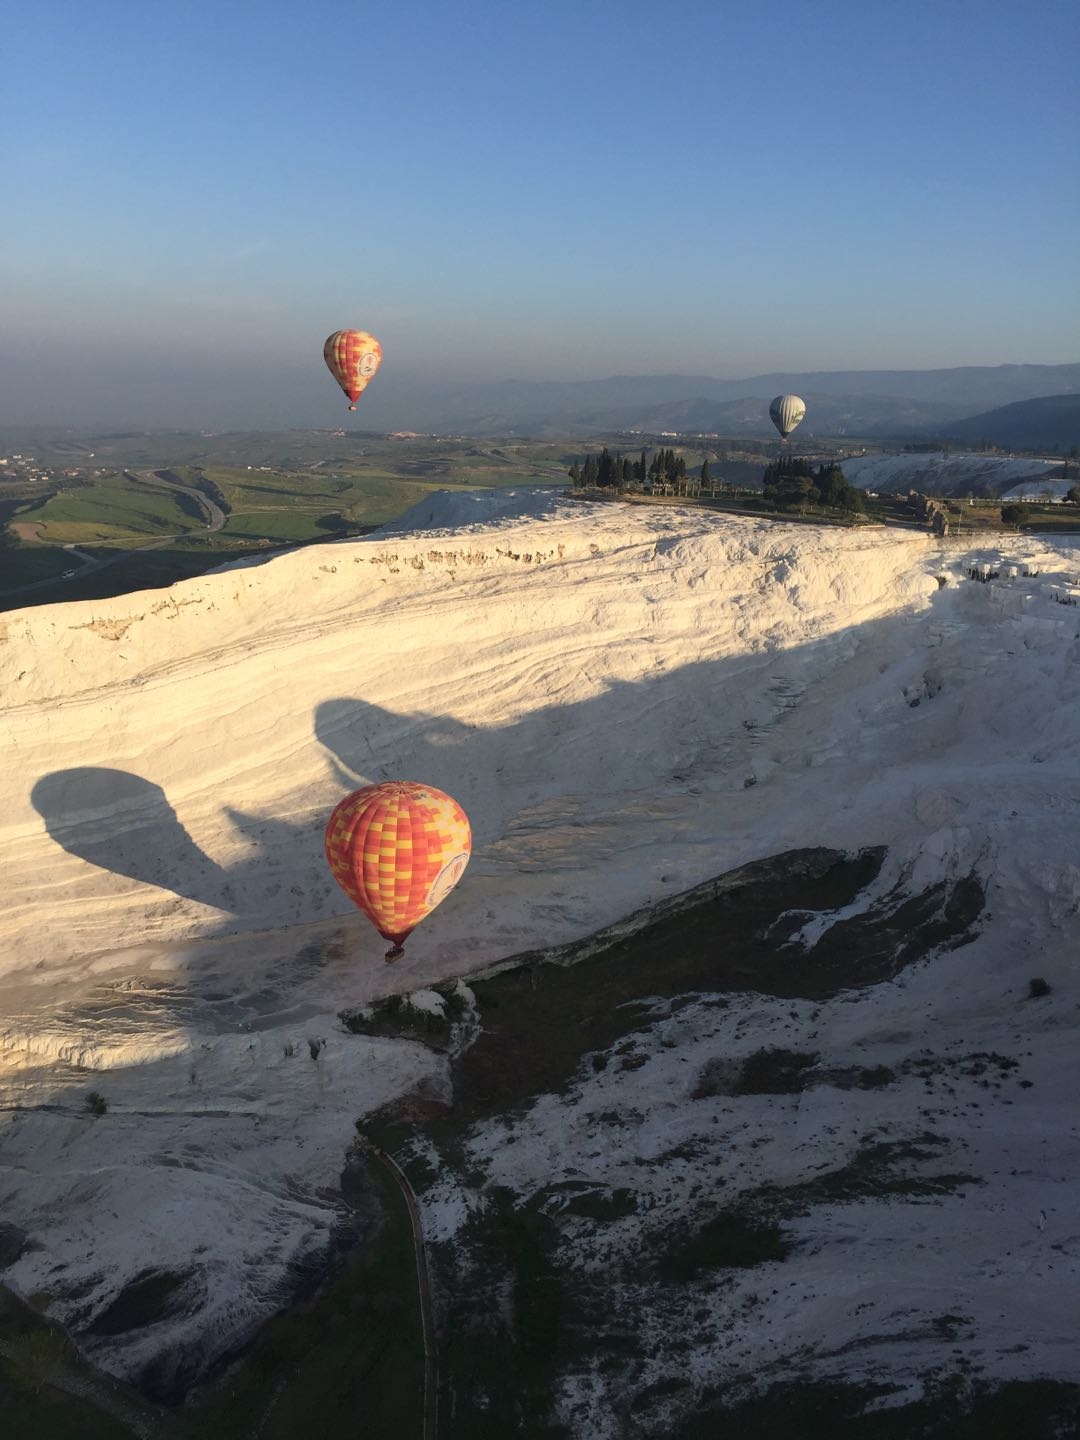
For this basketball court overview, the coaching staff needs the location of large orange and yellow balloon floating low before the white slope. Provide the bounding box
[325,780,472,960]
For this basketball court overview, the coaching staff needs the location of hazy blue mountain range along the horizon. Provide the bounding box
[413,364,1080,444]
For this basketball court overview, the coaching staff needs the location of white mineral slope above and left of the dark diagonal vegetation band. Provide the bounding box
[0,491,1080,1393]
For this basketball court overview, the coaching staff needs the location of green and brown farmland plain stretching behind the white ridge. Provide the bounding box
[0,431,1080,609]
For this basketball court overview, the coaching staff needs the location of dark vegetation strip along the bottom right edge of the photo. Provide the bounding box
[670,1380,1080,1440]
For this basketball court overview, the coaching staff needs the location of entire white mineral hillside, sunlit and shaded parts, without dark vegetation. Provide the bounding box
[0,490,1080,1437]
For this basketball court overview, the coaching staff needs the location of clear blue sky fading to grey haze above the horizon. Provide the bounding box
[0,0,1080,428]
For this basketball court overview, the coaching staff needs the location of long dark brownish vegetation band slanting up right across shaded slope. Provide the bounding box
[440,850,984,1122]
